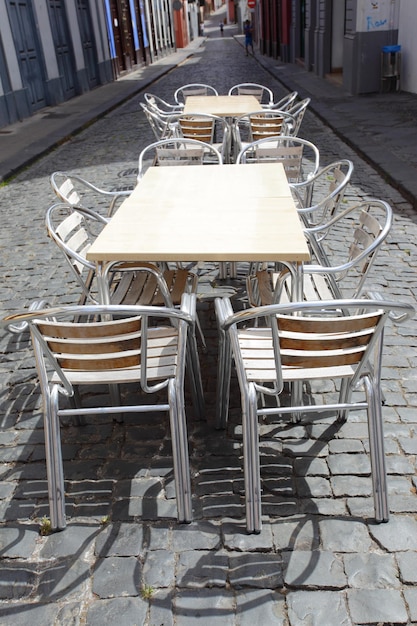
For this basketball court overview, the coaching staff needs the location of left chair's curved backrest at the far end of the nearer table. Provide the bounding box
[138,138,223,182]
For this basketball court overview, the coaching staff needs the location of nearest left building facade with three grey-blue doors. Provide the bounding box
[0,0,112,126]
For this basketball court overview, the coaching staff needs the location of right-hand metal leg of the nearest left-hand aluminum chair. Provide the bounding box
[168,380,193,523]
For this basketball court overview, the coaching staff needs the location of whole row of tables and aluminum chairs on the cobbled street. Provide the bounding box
[2,83,414,533]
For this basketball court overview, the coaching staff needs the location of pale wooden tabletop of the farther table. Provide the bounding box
[184,96,262,117]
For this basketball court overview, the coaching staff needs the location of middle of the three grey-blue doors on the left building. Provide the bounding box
[48,0,75,100]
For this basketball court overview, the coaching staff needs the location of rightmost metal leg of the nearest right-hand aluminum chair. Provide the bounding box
[364,376,389,522]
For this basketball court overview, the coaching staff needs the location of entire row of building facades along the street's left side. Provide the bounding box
[0,0,204,128]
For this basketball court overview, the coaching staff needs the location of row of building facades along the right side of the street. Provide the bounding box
[252,0,417,95]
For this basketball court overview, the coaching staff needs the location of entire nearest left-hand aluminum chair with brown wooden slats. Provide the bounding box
[1,294,203,530]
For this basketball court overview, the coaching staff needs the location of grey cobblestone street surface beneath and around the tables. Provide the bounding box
[0,6,417,626]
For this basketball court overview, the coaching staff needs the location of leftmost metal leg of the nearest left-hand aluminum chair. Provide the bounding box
[44,386,66,530]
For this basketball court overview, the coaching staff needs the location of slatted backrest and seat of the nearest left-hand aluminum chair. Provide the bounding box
[2,302,195,400]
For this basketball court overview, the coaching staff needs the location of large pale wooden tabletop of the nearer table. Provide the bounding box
[87,163,310,262]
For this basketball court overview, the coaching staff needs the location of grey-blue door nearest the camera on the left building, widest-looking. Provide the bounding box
[7,0,47,112]
